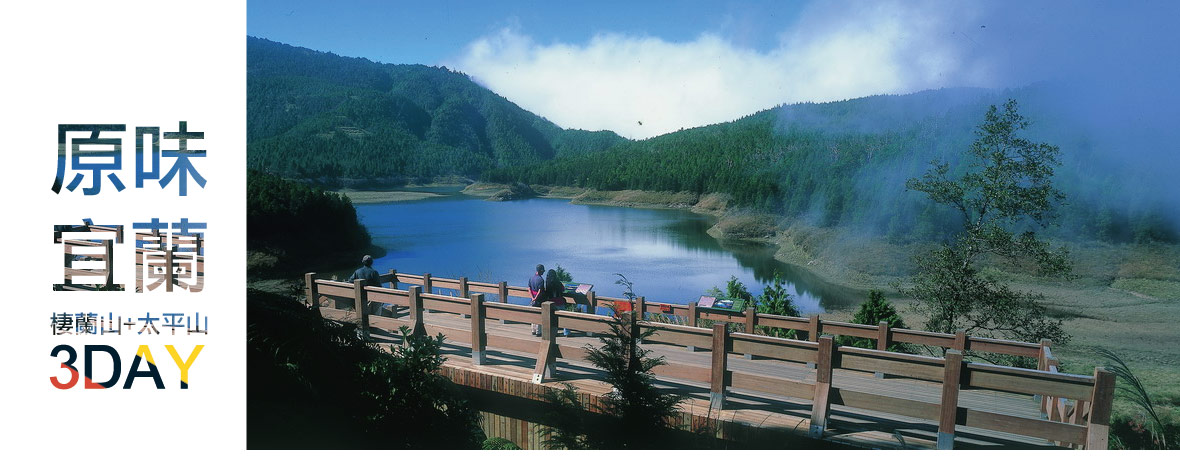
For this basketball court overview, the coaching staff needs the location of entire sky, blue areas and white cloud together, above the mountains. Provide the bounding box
[247,0,1180,138]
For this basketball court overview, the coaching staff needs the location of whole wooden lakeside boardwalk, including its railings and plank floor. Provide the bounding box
[304,270,1114,449]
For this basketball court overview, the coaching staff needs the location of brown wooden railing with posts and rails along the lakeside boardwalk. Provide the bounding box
[304,270,1114,449]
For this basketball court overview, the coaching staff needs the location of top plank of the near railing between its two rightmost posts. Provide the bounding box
[964,364,1094,400]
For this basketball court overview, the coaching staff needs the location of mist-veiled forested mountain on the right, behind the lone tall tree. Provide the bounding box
[483,84,1178,242]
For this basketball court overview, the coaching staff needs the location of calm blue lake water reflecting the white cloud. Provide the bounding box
[356,190,858,313]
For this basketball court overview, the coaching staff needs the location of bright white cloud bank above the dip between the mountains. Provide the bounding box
[452,2,995,138]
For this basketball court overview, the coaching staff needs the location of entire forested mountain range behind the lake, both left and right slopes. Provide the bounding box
[248,38,1180,242]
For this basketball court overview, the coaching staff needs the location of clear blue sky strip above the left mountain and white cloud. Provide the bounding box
[247,0,805,65]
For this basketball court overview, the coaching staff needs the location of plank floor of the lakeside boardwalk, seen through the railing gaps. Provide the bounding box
[321,308,1054,449]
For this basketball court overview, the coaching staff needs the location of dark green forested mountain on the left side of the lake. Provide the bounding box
[247,38,623,180]
